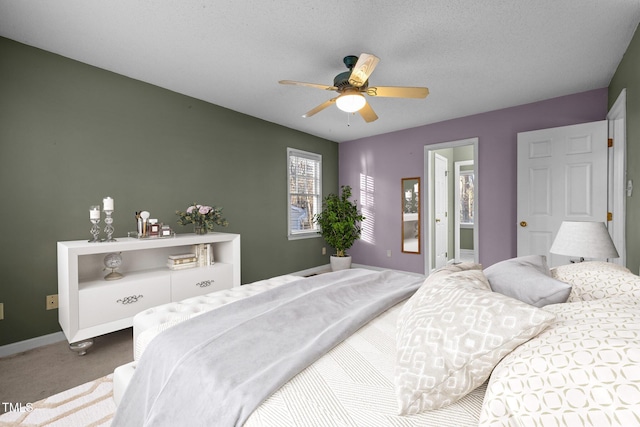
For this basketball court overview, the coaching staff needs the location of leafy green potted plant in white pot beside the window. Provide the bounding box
[314,185,365,271]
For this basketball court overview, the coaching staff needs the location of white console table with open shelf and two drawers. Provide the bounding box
[58,233,240,354]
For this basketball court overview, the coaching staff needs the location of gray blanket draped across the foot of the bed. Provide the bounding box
[112,269,423,427]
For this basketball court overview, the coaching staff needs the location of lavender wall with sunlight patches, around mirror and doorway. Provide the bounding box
[339,88,607,273]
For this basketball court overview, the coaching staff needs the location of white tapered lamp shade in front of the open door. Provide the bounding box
[549,221,620,258]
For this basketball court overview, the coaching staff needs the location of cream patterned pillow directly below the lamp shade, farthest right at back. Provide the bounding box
[551,261,640,302]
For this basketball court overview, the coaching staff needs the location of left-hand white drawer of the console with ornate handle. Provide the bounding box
[78,272,171,328]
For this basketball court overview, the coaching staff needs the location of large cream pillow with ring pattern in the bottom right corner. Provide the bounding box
[480,297,640,427]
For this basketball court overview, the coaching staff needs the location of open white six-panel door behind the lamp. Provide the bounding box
[517,120,608,266]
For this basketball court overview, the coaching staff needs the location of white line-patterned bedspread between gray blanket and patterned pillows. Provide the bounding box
[245,296,486,427]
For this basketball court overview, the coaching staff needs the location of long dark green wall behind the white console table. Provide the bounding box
[0,38,338,345]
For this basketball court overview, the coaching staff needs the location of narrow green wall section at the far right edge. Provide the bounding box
[609,25,640,274]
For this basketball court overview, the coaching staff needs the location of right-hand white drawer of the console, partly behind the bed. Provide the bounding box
[171,262,233,301]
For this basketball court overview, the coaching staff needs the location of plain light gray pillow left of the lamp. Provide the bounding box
[484,255,571,307]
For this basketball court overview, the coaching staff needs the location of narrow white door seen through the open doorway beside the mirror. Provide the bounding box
[433,153,449,269]
